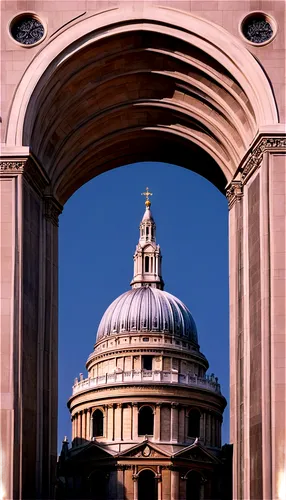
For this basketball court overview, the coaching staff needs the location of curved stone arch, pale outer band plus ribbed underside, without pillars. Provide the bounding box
[7,7,277,204]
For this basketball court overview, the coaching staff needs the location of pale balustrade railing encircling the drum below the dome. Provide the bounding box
[73,370,220,395]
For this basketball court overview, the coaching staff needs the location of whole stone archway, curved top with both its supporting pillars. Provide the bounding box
[1,2,285,498]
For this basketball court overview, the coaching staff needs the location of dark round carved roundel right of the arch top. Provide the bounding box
[241,12,276,45]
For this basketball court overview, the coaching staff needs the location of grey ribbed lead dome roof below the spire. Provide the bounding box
[96,287,198,343]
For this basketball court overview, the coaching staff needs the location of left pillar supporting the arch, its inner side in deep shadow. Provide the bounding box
[0,158,61,498]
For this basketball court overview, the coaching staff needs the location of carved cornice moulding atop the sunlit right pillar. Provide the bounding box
[226,133,286,210]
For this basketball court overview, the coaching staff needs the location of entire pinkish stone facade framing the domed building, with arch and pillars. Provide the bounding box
[0,0,286,500]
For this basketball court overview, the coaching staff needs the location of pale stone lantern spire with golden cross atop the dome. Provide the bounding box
[131,187,164,290]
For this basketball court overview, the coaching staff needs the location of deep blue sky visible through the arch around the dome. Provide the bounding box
[58,162,229,446]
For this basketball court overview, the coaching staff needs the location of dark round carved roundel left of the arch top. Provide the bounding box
[10,14,45,45]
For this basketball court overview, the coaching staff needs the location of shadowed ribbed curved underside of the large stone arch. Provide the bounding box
[20,24,268,203]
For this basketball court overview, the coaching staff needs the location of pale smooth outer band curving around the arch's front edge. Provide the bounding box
[7,7,278,146]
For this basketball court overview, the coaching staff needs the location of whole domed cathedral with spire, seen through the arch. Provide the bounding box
[57,196,231,500]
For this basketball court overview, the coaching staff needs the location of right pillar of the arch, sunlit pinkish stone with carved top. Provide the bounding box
[227,137,286,500]
